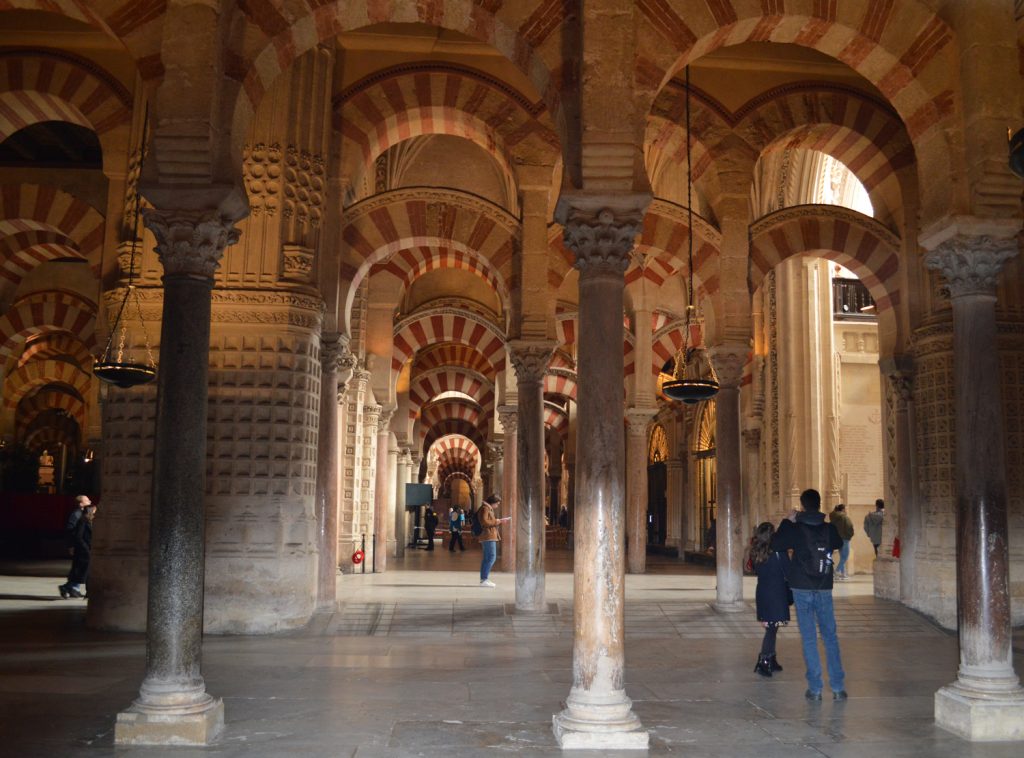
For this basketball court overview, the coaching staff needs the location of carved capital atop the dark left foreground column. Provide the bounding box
[142,208,242,279]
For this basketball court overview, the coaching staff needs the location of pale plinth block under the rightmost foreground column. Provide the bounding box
[935,682,1024,742]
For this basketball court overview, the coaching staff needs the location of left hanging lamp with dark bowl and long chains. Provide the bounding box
[92,106,157,389]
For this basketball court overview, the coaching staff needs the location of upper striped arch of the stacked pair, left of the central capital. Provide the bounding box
[332,61,560,201]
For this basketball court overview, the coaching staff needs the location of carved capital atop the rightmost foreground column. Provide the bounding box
[925,235,1018,299]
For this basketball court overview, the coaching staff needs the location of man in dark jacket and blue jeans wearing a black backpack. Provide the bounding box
[771,490,846,701]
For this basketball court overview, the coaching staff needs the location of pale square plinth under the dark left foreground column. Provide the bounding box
[114,698,224,745]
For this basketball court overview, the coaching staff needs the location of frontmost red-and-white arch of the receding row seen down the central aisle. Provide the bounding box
[391,308,505,377]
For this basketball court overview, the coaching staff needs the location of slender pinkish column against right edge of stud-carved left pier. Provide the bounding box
[316,334,355,612]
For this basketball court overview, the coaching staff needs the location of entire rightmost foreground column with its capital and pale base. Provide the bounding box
[925,235,1024,741]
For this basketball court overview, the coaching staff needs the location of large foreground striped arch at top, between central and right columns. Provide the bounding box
[635,0,958,138]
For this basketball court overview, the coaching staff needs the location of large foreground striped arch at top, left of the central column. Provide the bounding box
[228,0,565,156]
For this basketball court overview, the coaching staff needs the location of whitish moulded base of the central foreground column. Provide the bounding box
[551,690,649,750]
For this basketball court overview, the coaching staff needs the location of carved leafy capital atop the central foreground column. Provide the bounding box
[555,193,651,277]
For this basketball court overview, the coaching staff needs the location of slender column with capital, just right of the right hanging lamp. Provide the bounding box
[709,344,749,613]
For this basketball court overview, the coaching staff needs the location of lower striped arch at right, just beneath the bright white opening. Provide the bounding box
[749,205,901,318]
